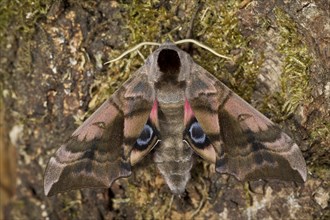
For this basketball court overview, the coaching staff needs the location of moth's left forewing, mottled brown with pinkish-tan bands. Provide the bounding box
[44,71,155,196]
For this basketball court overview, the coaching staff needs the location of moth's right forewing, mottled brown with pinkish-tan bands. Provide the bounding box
[186,64,307,182]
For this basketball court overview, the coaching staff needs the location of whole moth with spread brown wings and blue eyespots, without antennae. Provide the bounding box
[44,42,307,196]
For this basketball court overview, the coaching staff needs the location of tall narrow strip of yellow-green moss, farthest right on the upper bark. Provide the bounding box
[275,8,312,119]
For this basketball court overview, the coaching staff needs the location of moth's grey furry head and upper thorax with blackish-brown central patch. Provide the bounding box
[146,41,192,82]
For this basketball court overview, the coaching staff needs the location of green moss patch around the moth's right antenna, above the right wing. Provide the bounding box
[195,0,261,100]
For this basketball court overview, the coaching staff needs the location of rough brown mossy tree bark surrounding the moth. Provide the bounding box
[0,0,330,219]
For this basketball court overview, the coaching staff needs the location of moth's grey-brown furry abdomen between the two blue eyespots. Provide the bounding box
[154,100,193,194]
